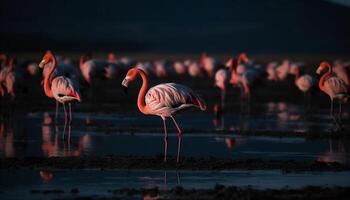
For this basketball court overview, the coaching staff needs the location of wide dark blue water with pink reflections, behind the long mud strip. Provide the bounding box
[0,103,350,163]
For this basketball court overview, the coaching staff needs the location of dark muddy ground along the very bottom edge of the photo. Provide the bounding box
[26,185,350,200]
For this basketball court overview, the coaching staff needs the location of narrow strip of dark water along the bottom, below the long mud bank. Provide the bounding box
[0,170,350,199]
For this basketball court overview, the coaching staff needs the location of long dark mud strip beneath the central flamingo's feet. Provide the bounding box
[0,155,350,172]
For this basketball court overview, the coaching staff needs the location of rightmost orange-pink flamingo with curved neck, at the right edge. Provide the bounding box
[316,62,349,124]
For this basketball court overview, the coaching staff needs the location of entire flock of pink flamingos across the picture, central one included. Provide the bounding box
[0,50,350,162]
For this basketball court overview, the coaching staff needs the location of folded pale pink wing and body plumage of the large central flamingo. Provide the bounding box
[145,83,206,116]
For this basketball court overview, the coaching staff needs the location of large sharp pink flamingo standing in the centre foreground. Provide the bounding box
[122,66,206,162]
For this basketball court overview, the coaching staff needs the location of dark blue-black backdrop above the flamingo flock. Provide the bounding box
[0,0,350,53]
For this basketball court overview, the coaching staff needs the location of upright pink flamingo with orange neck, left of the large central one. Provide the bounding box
[39,50,81,138]
